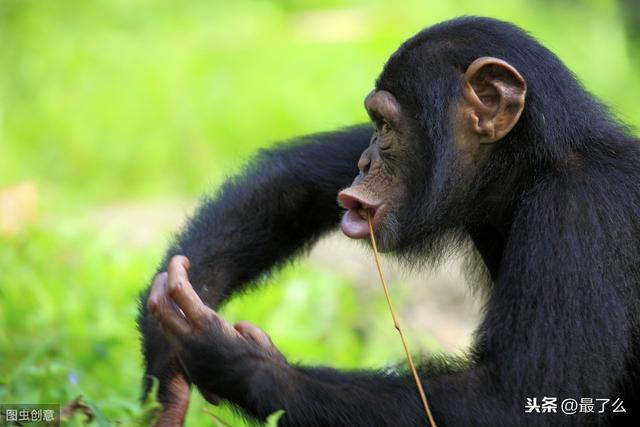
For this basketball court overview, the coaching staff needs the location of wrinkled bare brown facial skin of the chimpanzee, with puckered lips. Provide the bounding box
[338,90,413,251]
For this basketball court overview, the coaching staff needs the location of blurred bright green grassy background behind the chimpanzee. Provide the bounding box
[0,0,640,426]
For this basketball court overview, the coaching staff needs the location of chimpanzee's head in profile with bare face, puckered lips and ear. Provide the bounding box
[338,21,528,251]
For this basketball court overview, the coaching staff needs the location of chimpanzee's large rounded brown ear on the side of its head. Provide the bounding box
[464,56,527,144]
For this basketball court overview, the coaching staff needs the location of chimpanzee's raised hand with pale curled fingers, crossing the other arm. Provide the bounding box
[148,256,289,404]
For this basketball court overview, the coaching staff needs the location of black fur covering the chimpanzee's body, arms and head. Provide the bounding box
[140,18,640,426]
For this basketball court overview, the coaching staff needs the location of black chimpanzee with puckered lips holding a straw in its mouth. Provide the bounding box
[140,17,640,427]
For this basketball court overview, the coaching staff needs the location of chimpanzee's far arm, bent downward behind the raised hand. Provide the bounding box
[139,125,372,425]
